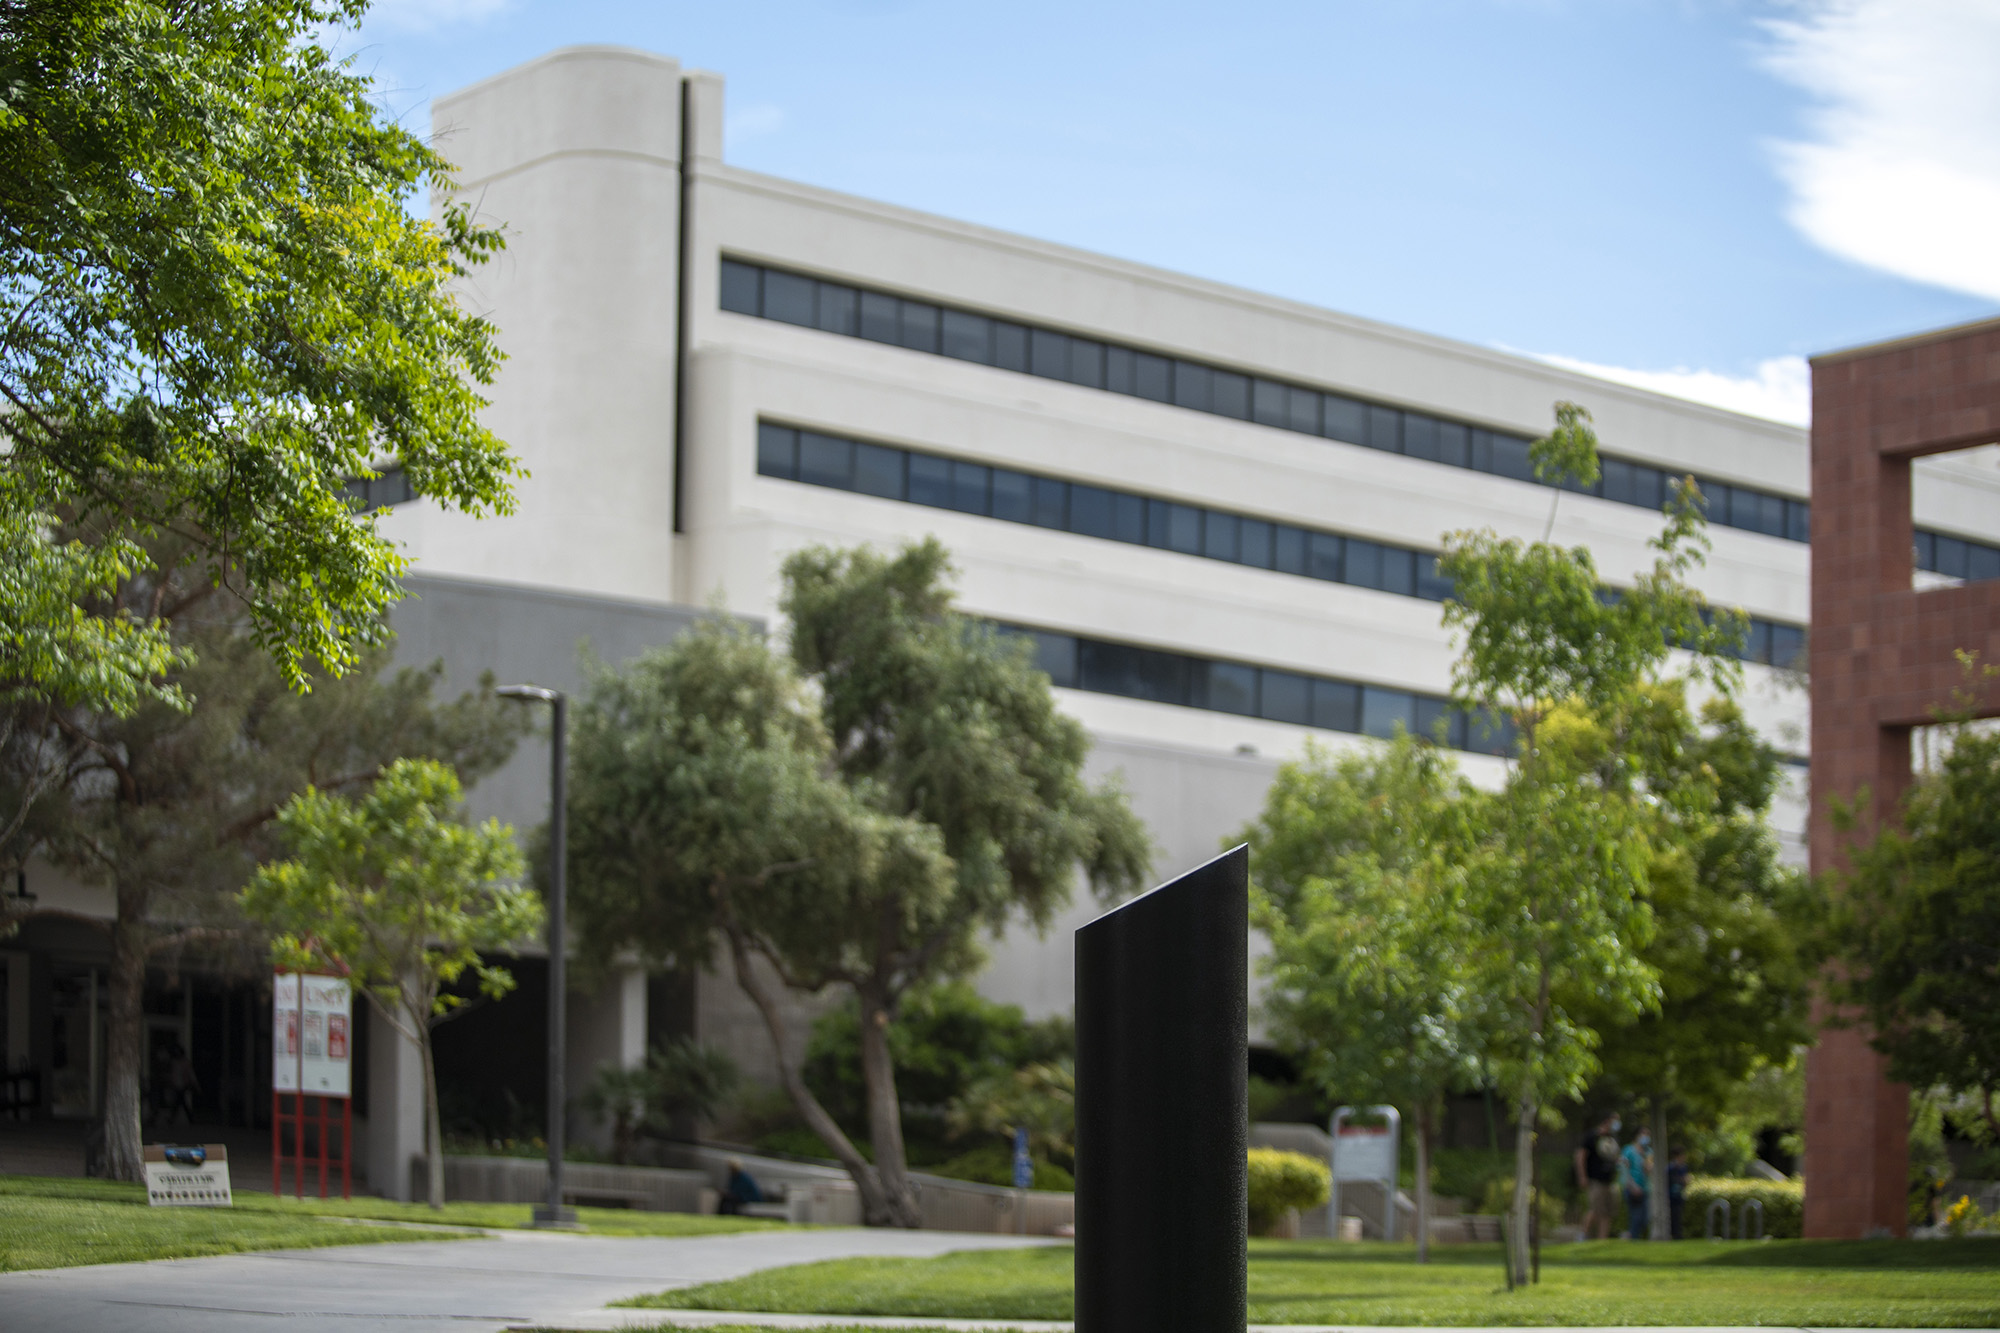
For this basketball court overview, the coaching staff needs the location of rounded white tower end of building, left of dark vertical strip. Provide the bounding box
[418,46,682,600]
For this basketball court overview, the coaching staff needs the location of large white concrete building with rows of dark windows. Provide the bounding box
[10,48,2000,1171]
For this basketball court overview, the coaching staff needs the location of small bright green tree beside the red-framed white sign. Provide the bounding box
[242,759,542,1209]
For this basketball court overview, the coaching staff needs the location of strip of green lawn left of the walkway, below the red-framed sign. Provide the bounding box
[0,1175,780,1271]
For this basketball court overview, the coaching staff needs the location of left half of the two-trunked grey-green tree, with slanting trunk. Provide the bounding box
[570,618,952,1225]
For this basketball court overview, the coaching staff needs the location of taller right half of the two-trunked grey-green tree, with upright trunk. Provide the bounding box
[782,538,1150,1225]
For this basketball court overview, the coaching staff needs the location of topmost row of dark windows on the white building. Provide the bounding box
[722,260,2000,578]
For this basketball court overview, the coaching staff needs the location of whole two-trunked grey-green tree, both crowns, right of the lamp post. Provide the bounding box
[570,540,1148,1225]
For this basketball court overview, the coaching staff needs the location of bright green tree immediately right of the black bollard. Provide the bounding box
[1240,733,1484,1263]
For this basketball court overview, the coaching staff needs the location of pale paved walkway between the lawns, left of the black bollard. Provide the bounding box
[0,1229,1046,1333]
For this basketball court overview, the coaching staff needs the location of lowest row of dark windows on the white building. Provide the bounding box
[998,624,1514,757]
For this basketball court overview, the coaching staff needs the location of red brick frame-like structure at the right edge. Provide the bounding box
[1804,320,2000,1237]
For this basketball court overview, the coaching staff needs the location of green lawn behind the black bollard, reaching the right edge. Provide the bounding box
[628,1241,2000,1327]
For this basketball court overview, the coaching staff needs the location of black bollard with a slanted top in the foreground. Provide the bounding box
[1076,847,1250,1333]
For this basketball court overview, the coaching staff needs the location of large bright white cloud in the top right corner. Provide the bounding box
[1766,0,2000,300]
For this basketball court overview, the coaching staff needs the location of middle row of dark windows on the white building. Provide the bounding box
[756,420,1806,667]
